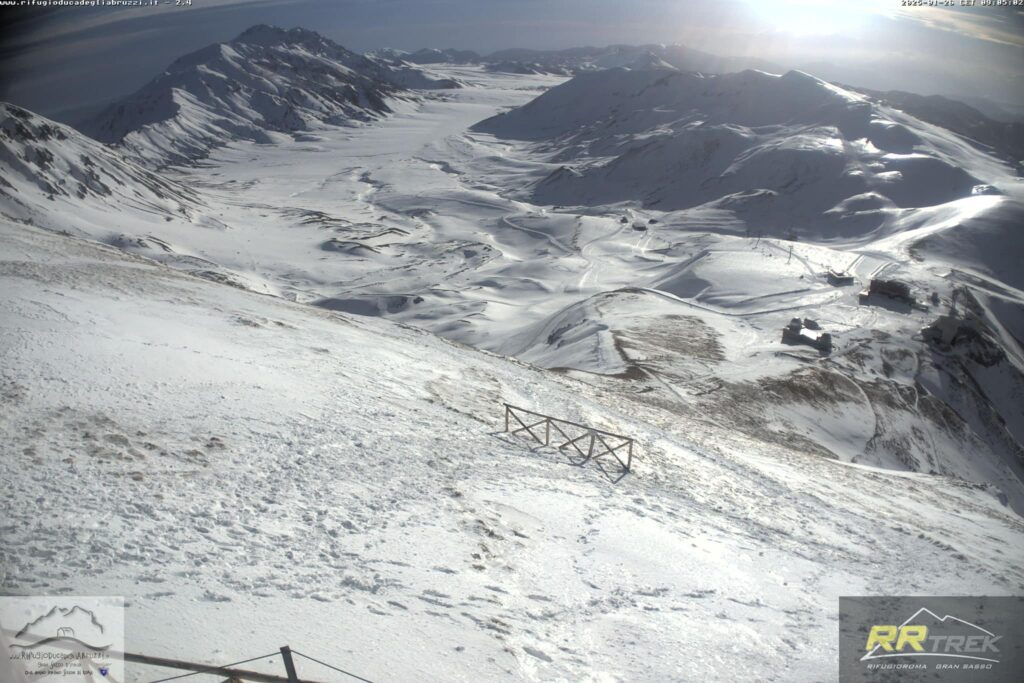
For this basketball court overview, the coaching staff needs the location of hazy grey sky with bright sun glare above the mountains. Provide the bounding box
[0,0,1024,120]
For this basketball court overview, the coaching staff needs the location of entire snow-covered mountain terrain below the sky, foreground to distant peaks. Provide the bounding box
[0,27,1024,681]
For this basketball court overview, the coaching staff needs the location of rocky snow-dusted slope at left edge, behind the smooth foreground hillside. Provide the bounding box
[0,103,274,292]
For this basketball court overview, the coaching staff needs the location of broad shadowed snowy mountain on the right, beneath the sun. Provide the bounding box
[475,69,1014,239]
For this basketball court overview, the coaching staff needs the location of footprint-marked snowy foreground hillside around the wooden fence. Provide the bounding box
[0,220,1024,682]
